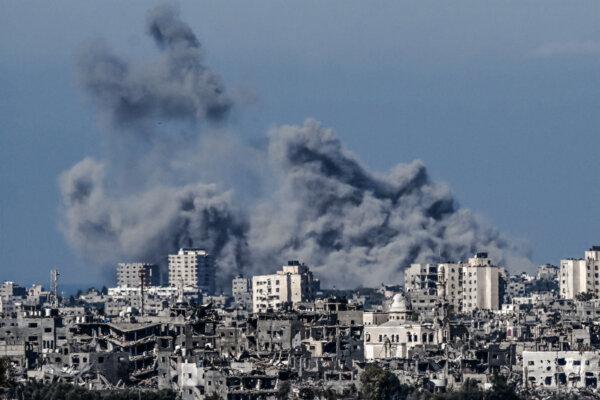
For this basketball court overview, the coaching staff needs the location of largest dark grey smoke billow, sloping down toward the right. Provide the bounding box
[250,120,530,286]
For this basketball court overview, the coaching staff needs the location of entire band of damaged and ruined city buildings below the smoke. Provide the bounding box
[5,247,600,400]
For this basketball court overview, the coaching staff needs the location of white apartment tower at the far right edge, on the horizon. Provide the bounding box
[559,246,600,299]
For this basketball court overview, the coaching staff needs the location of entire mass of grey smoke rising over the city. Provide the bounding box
[60,6,530,287]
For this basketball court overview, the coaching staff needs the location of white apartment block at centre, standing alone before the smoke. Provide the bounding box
[252,261,319,313]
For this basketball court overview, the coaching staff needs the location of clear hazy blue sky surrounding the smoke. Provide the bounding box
[0,1,600,284]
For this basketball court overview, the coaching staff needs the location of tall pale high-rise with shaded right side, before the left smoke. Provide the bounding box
[169,248,216,294]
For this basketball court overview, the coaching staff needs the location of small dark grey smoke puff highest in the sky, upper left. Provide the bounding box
[78,6,233,135]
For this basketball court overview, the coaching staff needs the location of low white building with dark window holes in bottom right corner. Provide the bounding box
[523,351,600,389]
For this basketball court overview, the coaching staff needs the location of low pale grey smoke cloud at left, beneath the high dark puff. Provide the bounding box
[60,158,248,280]
